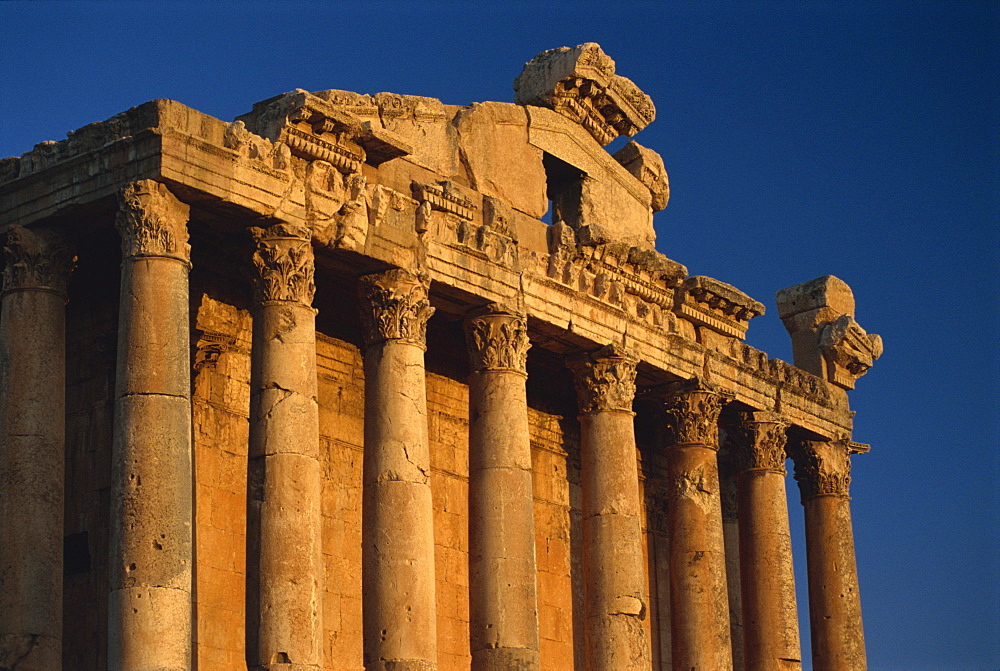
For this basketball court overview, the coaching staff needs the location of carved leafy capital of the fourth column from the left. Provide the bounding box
[358,268,434,347]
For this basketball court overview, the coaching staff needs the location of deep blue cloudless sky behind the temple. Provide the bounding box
[0,1,1000,671]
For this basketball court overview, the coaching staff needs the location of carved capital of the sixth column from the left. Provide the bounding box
[567,345,639,415]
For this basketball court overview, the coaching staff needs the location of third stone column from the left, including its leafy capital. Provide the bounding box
[248,223,324,671]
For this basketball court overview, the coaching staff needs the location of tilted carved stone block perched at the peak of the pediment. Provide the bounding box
[514,42,656,145]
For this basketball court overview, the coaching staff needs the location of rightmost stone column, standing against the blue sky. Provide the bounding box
[792,441,868,671]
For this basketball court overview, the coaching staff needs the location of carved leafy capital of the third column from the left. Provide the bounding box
[250,223,316,305]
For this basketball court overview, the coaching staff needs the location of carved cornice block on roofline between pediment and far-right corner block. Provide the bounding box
[674,275,764,340]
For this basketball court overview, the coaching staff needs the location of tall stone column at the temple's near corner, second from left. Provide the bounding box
[108,180,194,671]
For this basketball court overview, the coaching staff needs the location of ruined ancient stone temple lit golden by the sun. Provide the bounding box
[0,44,881,671]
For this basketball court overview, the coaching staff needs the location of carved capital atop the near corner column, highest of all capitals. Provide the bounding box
[115,179,191,262]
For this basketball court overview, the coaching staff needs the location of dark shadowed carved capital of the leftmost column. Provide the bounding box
[3,225,75,296]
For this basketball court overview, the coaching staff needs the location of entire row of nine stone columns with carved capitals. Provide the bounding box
[0,181,864,671]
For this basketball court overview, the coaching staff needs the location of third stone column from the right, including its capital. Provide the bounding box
[666,383,733,671]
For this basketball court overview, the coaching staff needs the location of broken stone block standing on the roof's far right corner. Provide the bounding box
[777,275,882,389]
